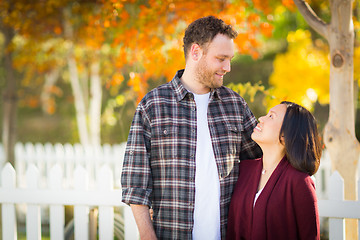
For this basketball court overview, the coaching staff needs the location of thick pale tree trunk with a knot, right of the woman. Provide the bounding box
[294,0,360,239]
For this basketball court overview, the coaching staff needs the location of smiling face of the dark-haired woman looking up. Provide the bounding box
[251,104,286,146]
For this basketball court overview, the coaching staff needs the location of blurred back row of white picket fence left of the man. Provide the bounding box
[0,143,126,191]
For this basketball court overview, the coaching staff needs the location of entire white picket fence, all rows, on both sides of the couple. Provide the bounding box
[0,143,360,239]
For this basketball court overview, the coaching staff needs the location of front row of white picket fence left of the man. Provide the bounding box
[0,163,138,240]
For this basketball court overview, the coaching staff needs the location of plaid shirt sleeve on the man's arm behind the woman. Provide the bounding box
[240,103,262,160]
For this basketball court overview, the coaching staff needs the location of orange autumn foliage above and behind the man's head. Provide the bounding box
[0,0,282,108]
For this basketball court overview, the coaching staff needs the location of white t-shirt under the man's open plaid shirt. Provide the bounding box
[192,93,221,240]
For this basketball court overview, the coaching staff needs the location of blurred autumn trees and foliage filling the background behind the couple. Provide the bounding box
[0,0,360,165]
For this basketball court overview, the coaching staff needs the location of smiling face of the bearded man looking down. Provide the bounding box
[196,34,234,89]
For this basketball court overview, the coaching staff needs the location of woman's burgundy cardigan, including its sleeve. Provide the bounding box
[226,157,320,240]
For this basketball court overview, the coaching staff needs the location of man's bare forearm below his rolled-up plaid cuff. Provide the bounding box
[130,204,157,240]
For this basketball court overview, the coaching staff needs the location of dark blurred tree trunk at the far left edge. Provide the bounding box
[1,22,17,167]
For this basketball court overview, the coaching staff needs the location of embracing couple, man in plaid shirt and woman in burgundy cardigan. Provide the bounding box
[121,16,321,240]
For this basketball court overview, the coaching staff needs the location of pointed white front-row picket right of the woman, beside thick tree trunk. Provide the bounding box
[328,171,345,240]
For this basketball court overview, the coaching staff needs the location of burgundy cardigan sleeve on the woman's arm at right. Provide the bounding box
[293,176,320,240]
